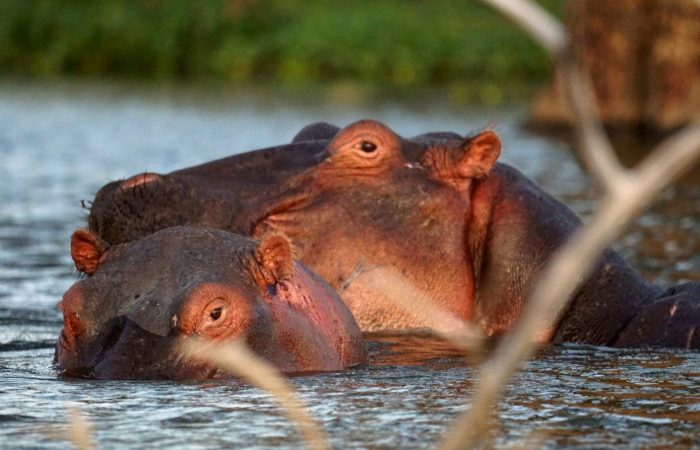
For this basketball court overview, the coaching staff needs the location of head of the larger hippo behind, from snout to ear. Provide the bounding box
[90,120,500,330]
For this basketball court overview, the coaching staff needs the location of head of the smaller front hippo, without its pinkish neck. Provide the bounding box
[55,227,340,379]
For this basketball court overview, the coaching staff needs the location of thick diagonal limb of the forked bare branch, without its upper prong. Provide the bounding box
[441,118,700,449]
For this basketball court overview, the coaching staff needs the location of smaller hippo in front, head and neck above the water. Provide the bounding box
[54,227,367,379]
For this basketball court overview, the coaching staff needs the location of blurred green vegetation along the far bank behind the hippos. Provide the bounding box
[0,0,562,100]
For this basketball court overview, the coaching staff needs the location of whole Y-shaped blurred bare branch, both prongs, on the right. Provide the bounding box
[442,0,700,449]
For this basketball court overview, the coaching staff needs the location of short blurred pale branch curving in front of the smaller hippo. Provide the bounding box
[181,340,330,450]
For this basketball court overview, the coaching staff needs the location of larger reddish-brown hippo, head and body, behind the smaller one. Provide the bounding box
[89,120,700,348]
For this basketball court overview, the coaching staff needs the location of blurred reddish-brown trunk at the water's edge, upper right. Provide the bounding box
[529,0,700,132]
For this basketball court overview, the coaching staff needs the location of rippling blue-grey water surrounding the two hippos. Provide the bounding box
[0,83,700,449]
